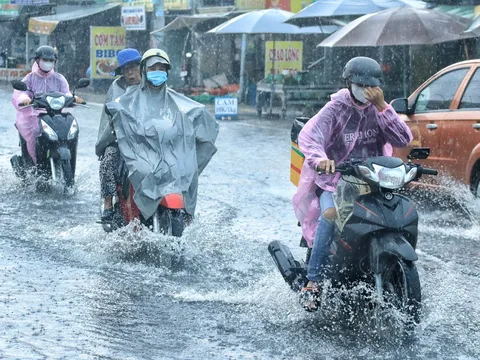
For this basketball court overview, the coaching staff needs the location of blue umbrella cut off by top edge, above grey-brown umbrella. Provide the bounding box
[286,0,426,26]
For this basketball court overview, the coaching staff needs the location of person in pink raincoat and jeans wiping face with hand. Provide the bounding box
[293,57,412,311]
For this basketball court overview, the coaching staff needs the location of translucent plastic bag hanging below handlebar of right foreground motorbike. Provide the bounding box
[333,176,371,231]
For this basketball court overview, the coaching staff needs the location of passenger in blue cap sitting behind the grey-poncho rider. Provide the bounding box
[95,49,142,222]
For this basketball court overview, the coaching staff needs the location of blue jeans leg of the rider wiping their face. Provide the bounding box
[307,191,335,282]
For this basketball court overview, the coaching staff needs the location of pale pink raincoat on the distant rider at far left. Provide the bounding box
[12,62,72,163]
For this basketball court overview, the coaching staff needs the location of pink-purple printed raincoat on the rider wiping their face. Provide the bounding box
[293,89,412,247]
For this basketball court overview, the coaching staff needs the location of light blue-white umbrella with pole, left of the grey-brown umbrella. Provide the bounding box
[207,9,338,113]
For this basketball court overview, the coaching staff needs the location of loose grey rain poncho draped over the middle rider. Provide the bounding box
[106,85,218,218]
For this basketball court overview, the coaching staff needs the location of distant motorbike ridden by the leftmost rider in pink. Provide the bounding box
[10,78,90,190]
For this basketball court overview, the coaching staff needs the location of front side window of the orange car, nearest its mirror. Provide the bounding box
[415,67,470,112]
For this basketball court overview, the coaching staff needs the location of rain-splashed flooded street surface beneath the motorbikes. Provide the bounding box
[0,90,480,360]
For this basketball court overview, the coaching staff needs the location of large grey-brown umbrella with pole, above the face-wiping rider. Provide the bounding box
[318,7,476,97]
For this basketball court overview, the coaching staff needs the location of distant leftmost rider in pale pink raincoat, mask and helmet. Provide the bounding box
[12,46,83,164]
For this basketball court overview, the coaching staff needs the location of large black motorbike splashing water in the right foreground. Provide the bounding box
[268,148,438,329]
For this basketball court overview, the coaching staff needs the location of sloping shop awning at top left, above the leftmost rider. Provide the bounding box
[28,3,120,35]
